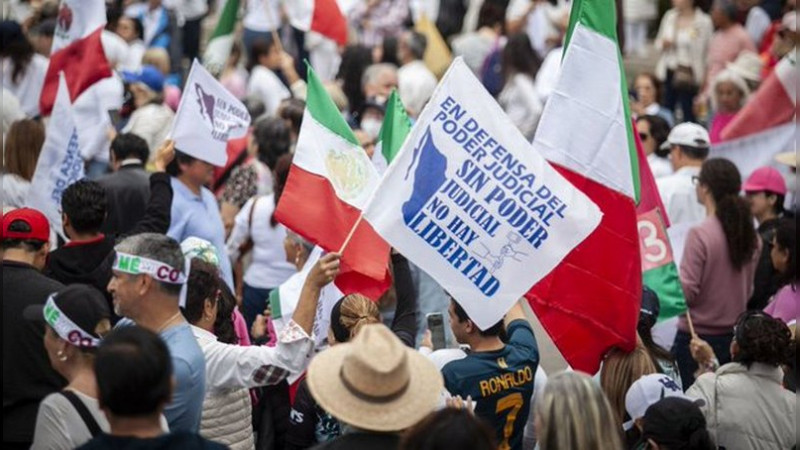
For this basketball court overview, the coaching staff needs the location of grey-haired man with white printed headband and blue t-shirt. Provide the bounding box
[108,233,205,432]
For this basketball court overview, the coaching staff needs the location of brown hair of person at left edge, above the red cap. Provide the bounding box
[3,119,45,181]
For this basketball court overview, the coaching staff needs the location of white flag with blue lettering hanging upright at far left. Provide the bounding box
[25,74,83,239]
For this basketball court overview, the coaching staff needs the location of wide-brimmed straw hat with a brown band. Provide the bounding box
[307,324,444,432]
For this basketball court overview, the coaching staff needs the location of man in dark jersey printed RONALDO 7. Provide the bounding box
[442,299,539,449]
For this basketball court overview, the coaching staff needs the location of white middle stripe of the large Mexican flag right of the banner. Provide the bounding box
[533,24,635,198]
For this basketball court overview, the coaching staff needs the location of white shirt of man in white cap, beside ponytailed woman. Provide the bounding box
[656,167,706,225]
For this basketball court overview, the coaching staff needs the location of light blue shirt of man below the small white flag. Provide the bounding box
[167,177,233,289]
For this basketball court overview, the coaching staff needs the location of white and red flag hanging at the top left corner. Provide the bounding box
[39,0,112,116]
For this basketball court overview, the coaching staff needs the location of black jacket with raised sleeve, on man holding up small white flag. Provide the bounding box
[44,173,172,318]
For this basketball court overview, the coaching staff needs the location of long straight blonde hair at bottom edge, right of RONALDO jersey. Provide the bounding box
[536,372,622,450]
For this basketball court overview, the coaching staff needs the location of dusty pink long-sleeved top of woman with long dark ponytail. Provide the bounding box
[678,217,761,335]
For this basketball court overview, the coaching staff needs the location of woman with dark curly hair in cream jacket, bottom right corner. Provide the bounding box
[686,311,797,450]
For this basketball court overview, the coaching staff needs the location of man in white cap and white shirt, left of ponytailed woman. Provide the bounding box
[656,122,711,225]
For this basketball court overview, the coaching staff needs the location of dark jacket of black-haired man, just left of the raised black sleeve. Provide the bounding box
[97,164,150,236]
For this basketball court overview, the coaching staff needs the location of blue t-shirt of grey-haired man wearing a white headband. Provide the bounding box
[159,322,206,433]
